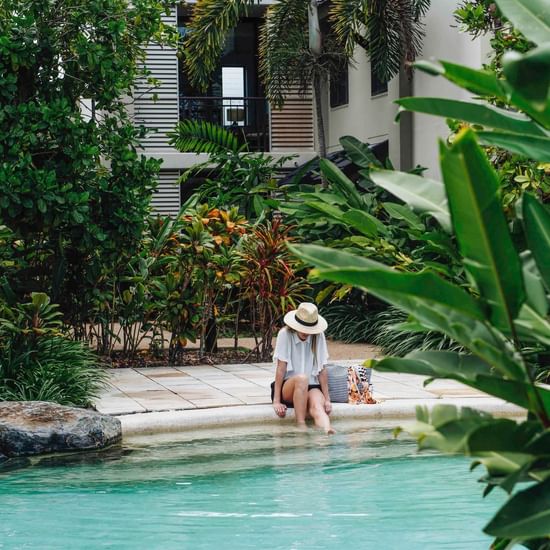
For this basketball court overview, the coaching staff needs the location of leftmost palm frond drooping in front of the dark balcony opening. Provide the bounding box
[183,0,258,91]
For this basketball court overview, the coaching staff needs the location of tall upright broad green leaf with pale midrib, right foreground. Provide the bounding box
[441,130,525,333]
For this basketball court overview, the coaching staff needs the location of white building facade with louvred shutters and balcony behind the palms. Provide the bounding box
[133,0,487,215]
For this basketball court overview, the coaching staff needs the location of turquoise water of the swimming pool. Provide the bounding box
[0,426,501,550]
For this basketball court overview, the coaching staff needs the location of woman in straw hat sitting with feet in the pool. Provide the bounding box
[271,302,335,434]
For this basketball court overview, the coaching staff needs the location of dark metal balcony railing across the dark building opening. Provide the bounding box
[180,96,270,151]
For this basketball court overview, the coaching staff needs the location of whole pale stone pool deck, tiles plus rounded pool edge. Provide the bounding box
[96,362,524,436]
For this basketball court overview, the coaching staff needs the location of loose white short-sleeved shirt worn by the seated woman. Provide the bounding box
[273,327,328,384]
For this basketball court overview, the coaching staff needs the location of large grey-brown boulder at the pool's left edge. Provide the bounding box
[0,401,122,458]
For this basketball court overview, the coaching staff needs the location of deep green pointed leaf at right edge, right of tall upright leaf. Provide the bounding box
[523,193,550,291]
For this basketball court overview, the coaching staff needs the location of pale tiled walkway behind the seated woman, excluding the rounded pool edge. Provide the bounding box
[96,360,492,415]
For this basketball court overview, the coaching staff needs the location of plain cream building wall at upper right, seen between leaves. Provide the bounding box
[327,0,488,177]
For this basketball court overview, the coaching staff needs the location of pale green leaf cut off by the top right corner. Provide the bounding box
[497,0,550,44]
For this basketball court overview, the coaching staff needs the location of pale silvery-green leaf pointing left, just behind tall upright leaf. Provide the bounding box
[370,170,452,233]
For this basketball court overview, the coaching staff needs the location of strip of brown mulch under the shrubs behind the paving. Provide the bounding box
[103,348,268,368]
